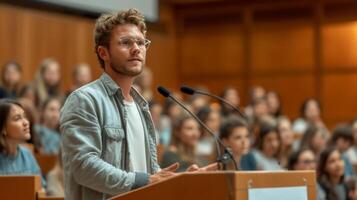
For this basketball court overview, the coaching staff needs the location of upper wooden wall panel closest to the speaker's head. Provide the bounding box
[179,15,244,76]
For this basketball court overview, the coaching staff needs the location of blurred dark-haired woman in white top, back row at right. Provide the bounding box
[293,98,328,136]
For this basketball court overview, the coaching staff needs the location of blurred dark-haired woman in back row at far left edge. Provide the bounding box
[0,61,22,99]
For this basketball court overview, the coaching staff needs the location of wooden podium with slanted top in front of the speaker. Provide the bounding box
[111,171,316,200]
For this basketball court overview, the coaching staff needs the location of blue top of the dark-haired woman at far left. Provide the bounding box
[0,146,45,186]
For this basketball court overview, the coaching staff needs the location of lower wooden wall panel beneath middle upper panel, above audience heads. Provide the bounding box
[252,74,315,119]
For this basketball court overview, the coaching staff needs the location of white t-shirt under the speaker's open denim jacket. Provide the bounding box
[124,101,147,173]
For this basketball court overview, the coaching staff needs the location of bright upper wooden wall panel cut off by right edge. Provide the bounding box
[322,21,357,69]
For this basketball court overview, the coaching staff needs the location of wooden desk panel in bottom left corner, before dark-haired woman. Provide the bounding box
[0,176,42,200]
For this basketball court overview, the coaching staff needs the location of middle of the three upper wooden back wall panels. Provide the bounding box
[251,20,314,72]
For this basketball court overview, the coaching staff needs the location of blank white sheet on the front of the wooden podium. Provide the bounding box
[248,186,307,200]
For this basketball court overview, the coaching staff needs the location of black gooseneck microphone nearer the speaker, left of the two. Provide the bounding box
[157,86,238,171]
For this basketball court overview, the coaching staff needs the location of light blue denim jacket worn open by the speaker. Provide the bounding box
[60,73,159,200]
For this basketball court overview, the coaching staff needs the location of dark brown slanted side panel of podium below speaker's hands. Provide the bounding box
[111,172,234,200]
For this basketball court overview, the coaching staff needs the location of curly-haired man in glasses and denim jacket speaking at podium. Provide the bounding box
[60,9,181,200]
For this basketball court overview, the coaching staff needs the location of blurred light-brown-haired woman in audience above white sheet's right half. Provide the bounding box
[277,117,294,168]
